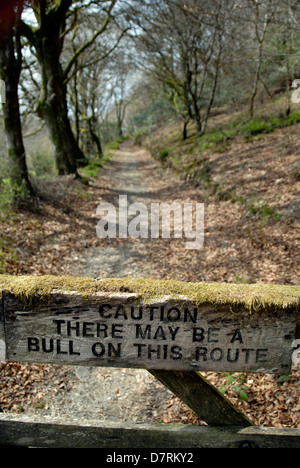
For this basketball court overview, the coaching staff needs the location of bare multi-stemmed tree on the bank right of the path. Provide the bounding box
[129,0,224,139]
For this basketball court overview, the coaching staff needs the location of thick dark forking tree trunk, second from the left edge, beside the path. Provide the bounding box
[22,0,87,175]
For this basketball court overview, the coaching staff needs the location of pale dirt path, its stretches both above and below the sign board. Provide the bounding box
[36,142,176,422]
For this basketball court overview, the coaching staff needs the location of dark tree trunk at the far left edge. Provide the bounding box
[0,0,33,195]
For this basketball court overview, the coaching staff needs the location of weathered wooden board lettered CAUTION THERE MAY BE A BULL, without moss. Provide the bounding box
[1,291,298,374]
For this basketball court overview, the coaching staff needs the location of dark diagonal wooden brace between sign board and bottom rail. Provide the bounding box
[149,370,253,427]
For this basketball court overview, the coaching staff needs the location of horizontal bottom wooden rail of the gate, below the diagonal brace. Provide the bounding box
[0,414,300,453]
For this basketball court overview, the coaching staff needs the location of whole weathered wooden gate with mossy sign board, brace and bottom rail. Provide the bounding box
[0,276,300,448]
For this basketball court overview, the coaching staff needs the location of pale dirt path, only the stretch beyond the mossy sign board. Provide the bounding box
[80,141,157,278]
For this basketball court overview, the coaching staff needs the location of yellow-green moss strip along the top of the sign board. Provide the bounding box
[0,275,300,312]
